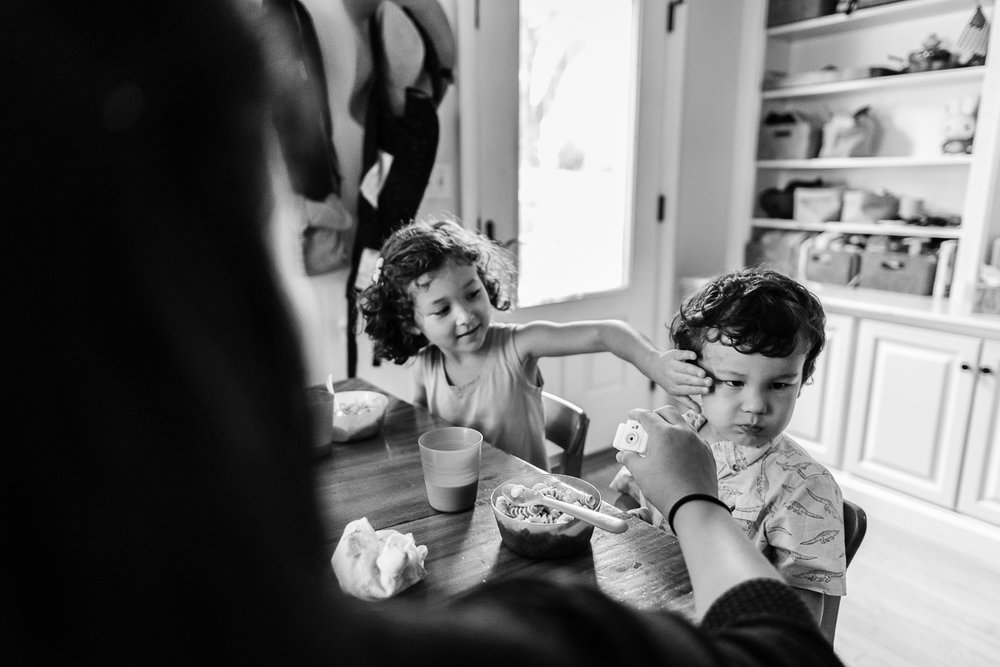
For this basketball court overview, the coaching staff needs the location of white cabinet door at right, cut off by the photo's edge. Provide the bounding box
[958,340,1000,526]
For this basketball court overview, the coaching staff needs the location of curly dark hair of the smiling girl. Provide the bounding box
[358,220,514,364]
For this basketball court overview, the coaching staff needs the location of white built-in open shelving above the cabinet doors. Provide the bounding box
[729,0,1000,310]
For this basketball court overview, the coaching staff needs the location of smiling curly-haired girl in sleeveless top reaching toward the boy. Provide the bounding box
[360,220,668,470]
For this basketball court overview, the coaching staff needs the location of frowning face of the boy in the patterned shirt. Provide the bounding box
[699,343,806,447]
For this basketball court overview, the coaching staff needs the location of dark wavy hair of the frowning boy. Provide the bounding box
[670,268,826,384]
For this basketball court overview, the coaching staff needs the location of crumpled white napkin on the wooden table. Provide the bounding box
[330,517,427,600]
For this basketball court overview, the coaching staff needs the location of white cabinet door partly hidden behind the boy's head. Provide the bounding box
[786,314,854,468]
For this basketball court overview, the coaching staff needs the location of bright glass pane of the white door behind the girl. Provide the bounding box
[517,0,638,306]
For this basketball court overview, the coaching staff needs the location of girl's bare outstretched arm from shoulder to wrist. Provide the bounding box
[514,320,671,391]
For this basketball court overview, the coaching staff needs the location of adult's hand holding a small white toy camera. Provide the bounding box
[617,405,719,515]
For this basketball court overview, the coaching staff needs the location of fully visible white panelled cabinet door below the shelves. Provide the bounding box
[845,321,981,509]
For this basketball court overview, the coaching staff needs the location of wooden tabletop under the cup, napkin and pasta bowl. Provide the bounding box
[316,378,694,618]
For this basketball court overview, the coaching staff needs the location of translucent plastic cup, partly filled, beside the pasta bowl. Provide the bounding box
[417,426,483,512]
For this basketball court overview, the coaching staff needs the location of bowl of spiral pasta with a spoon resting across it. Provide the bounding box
[490,473,601,558]
